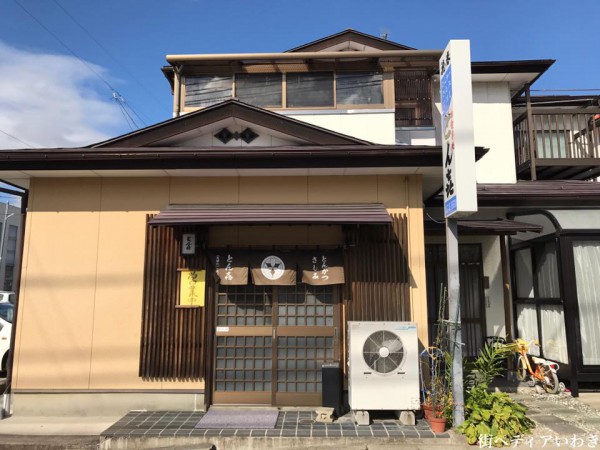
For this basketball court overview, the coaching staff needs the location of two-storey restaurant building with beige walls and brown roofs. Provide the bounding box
[0,30,600,414]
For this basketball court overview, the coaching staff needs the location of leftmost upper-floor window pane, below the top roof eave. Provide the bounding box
[185,75,233,107]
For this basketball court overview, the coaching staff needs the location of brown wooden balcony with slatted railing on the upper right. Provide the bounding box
[513,107,600,180]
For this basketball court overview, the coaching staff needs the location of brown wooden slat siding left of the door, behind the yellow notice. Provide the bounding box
[139,215,209,379]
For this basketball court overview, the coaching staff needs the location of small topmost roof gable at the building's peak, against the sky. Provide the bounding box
[286,29,415,53]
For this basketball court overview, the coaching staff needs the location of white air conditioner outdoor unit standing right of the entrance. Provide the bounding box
[348,322,421,425]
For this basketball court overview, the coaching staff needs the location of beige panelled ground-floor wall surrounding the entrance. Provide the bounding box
[14,176,427,390]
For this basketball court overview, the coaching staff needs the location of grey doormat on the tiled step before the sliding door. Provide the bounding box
[195,409,279,429]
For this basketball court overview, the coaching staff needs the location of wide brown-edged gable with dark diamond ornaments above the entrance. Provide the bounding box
[90,100,371,148]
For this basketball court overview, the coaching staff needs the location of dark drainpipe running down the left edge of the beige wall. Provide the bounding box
[0,186,29,419]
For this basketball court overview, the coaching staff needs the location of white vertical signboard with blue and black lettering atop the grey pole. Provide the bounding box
[440,40,477,218]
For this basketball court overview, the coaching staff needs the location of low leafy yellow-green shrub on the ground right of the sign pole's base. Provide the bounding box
[456,385,535,447]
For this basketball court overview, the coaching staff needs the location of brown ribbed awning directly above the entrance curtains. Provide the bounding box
[149,203,392,225]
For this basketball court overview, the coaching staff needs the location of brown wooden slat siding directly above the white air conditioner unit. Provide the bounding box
[344,214,411,321]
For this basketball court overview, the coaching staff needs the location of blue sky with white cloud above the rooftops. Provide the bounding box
[0,0,600,148]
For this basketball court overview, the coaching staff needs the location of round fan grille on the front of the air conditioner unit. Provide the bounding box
[363,330,404,374]
